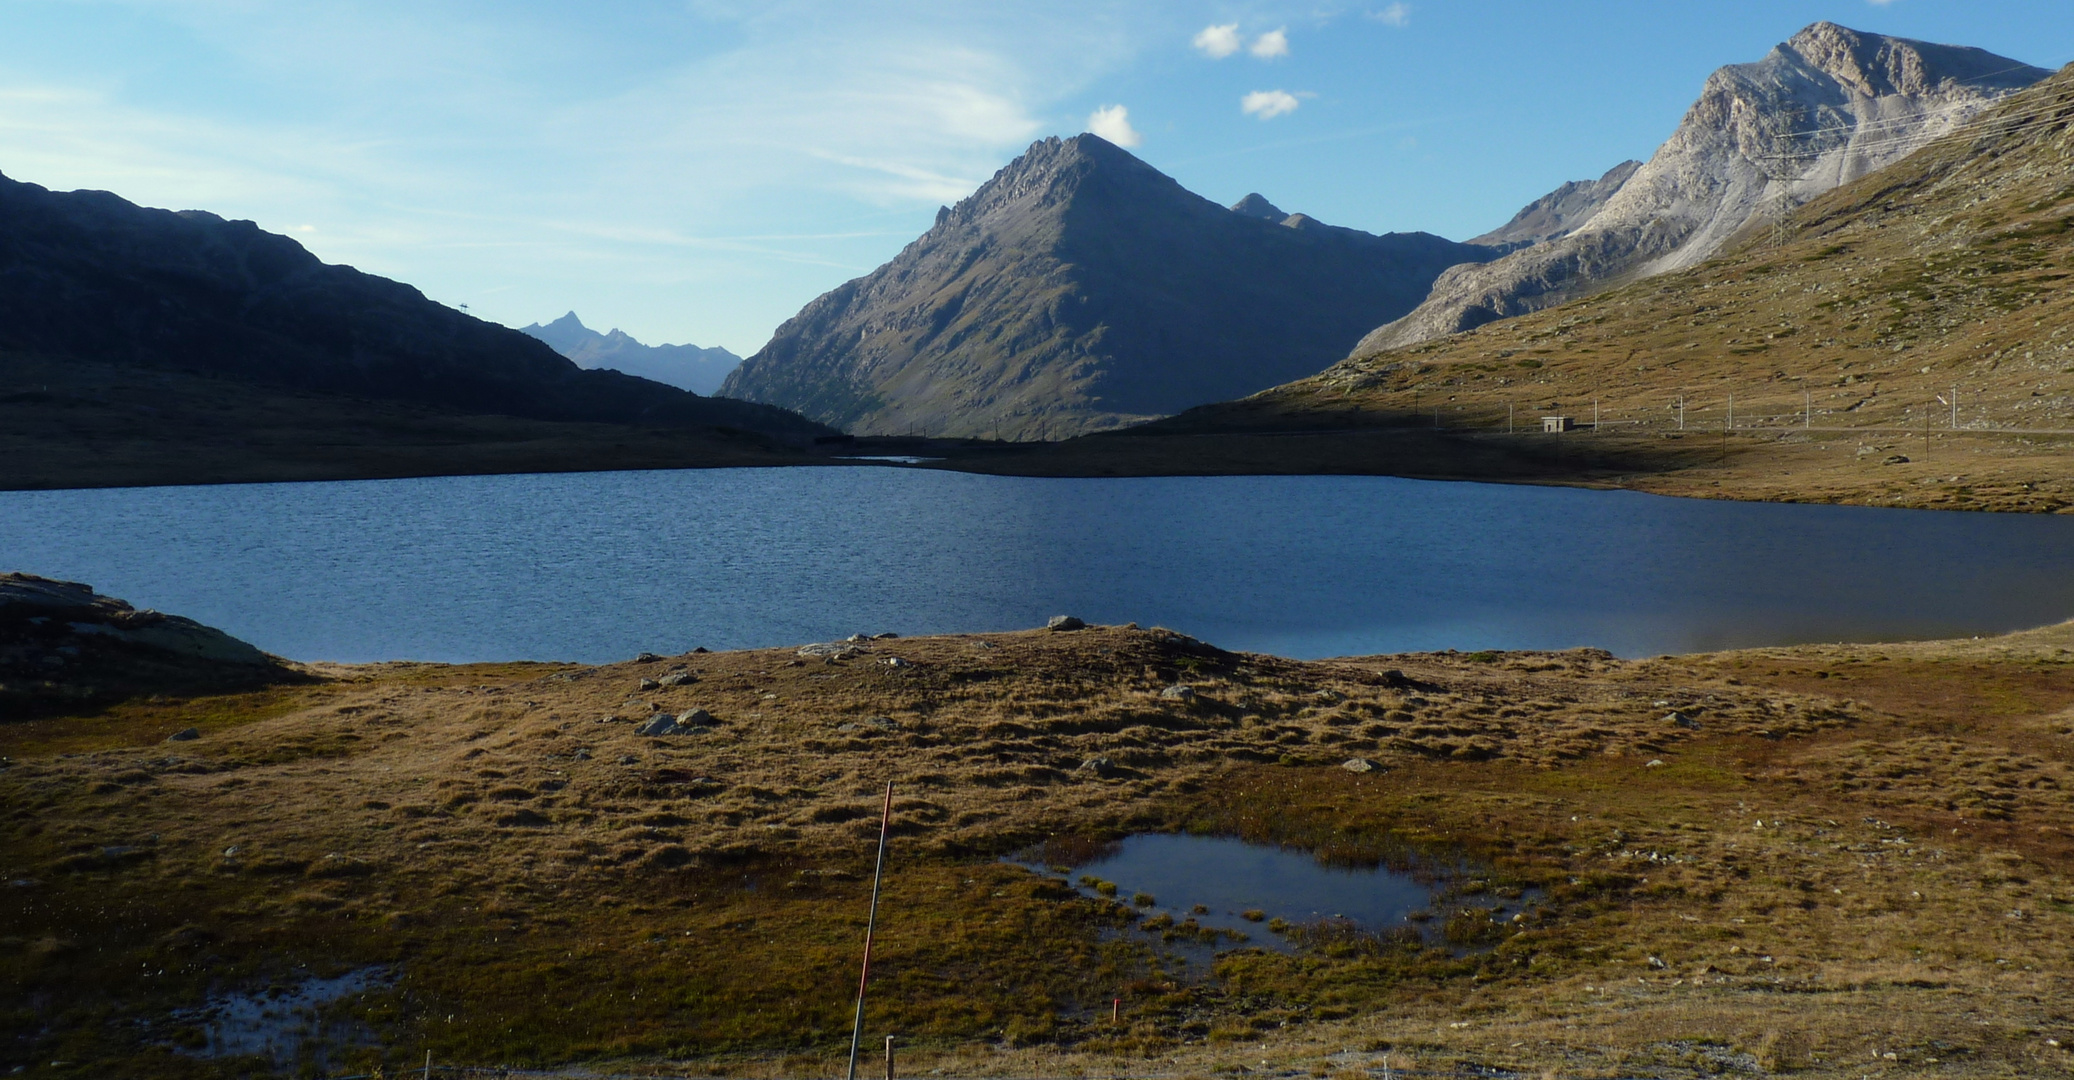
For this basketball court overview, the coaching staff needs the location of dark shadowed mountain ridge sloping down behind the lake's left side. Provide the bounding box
[0,176,825,437]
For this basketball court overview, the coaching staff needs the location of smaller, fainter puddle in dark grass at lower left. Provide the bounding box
[174,968,390,1070]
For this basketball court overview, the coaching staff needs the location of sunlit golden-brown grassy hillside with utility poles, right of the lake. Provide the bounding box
[1144,64,2074,512]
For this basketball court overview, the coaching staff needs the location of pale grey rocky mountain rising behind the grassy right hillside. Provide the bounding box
[1354,23,2049,354]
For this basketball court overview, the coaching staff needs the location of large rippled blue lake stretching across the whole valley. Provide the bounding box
[0,466,2074,661]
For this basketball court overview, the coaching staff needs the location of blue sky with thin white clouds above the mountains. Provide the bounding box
[0,0,2074,354]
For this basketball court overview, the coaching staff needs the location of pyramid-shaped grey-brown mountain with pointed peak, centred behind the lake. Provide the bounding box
[720,135,1493,439]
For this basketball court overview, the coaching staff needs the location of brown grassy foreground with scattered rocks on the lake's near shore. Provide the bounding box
[0,626,2074,1076]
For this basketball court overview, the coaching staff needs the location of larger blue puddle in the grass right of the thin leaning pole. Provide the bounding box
[1006,833,1526,962]
